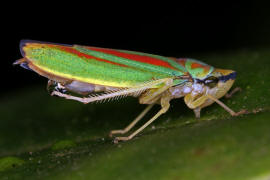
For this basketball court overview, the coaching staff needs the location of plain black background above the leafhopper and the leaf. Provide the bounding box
[1,1,270,91]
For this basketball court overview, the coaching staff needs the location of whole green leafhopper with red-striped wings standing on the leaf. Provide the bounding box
[14,40,247,142]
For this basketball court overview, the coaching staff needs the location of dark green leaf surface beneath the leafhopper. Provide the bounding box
[0,49,270,180]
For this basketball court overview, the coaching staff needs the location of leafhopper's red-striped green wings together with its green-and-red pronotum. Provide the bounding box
[18,41,213,87]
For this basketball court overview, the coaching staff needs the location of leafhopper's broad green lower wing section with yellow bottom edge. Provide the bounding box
[23,43,183,87]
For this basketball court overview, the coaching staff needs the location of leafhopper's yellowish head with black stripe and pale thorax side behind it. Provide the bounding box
[185,69,236,109]
